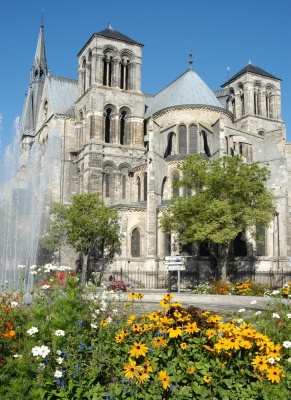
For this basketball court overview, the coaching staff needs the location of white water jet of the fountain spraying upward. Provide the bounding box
[0,119,57,292]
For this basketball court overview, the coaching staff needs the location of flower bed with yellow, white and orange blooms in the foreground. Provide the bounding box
[0,264,291,400]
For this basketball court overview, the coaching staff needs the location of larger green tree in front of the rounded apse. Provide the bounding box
[160,155,274,279]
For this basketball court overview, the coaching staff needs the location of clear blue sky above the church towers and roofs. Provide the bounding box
[0,0,291,152]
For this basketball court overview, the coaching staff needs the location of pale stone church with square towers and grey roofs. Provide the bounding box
[21,26,291,271]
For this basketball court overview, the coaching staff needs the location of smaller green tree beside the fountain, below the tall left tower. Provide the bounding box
[42,193,120,283]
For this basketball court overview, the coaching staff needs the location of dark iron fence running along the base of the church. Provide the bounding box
[94,268,291,291]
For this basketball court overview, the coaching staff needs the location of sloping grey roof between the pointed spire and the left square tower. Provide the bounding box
[46,76,78,116]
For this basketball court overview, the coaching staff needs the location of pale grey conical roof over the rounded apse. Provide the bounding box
[146,69,223,117]
